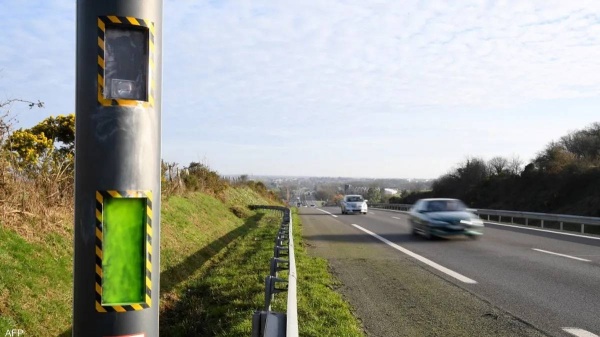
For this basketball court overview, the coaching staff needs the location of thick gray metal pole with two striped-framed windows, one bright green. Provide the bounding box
[73,0,163,337]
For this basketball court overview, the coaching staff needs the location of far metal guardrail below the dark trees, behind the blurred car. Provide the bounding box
[369,204,600,235]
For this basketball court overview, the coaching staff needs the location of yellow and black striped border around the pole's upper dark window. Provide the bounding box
[98,15,154,107]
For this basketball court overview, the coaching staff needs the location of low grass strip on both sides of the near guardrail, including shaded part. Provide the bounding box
[161,207,364,337]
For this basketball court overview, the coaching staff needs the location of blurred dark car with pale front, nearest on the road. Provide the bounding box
[409,198,483,239]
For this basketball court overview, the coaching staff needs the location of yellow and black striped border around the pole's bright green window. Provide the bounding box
[96,190,152,312]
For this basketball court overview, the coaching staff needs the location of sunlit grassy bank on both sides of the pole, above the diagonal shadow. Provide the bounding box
[0,188,268,336]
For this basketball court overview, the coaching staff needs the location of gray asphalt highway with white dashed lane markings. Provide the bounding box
[300,207,600,337]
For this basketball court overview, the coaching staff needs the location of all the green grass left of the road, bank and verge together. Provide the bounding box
[0,188,362,336]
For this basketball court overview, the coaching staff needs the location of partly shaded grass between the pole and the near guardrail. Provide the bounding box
[160,213,281,336]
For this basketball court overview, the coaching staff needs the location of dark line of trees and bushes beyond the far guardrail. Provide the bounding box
[390,122,600,216]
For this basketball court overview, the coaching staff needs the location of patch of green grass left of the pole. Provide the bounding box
[0,229,72,336]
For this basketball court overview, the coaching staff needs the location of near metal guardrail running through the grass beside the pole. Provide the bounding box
[250,205,298,337]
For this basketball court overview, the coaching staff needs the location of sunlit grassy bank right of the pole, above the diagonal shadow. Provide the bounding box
[161,188,268,294]
